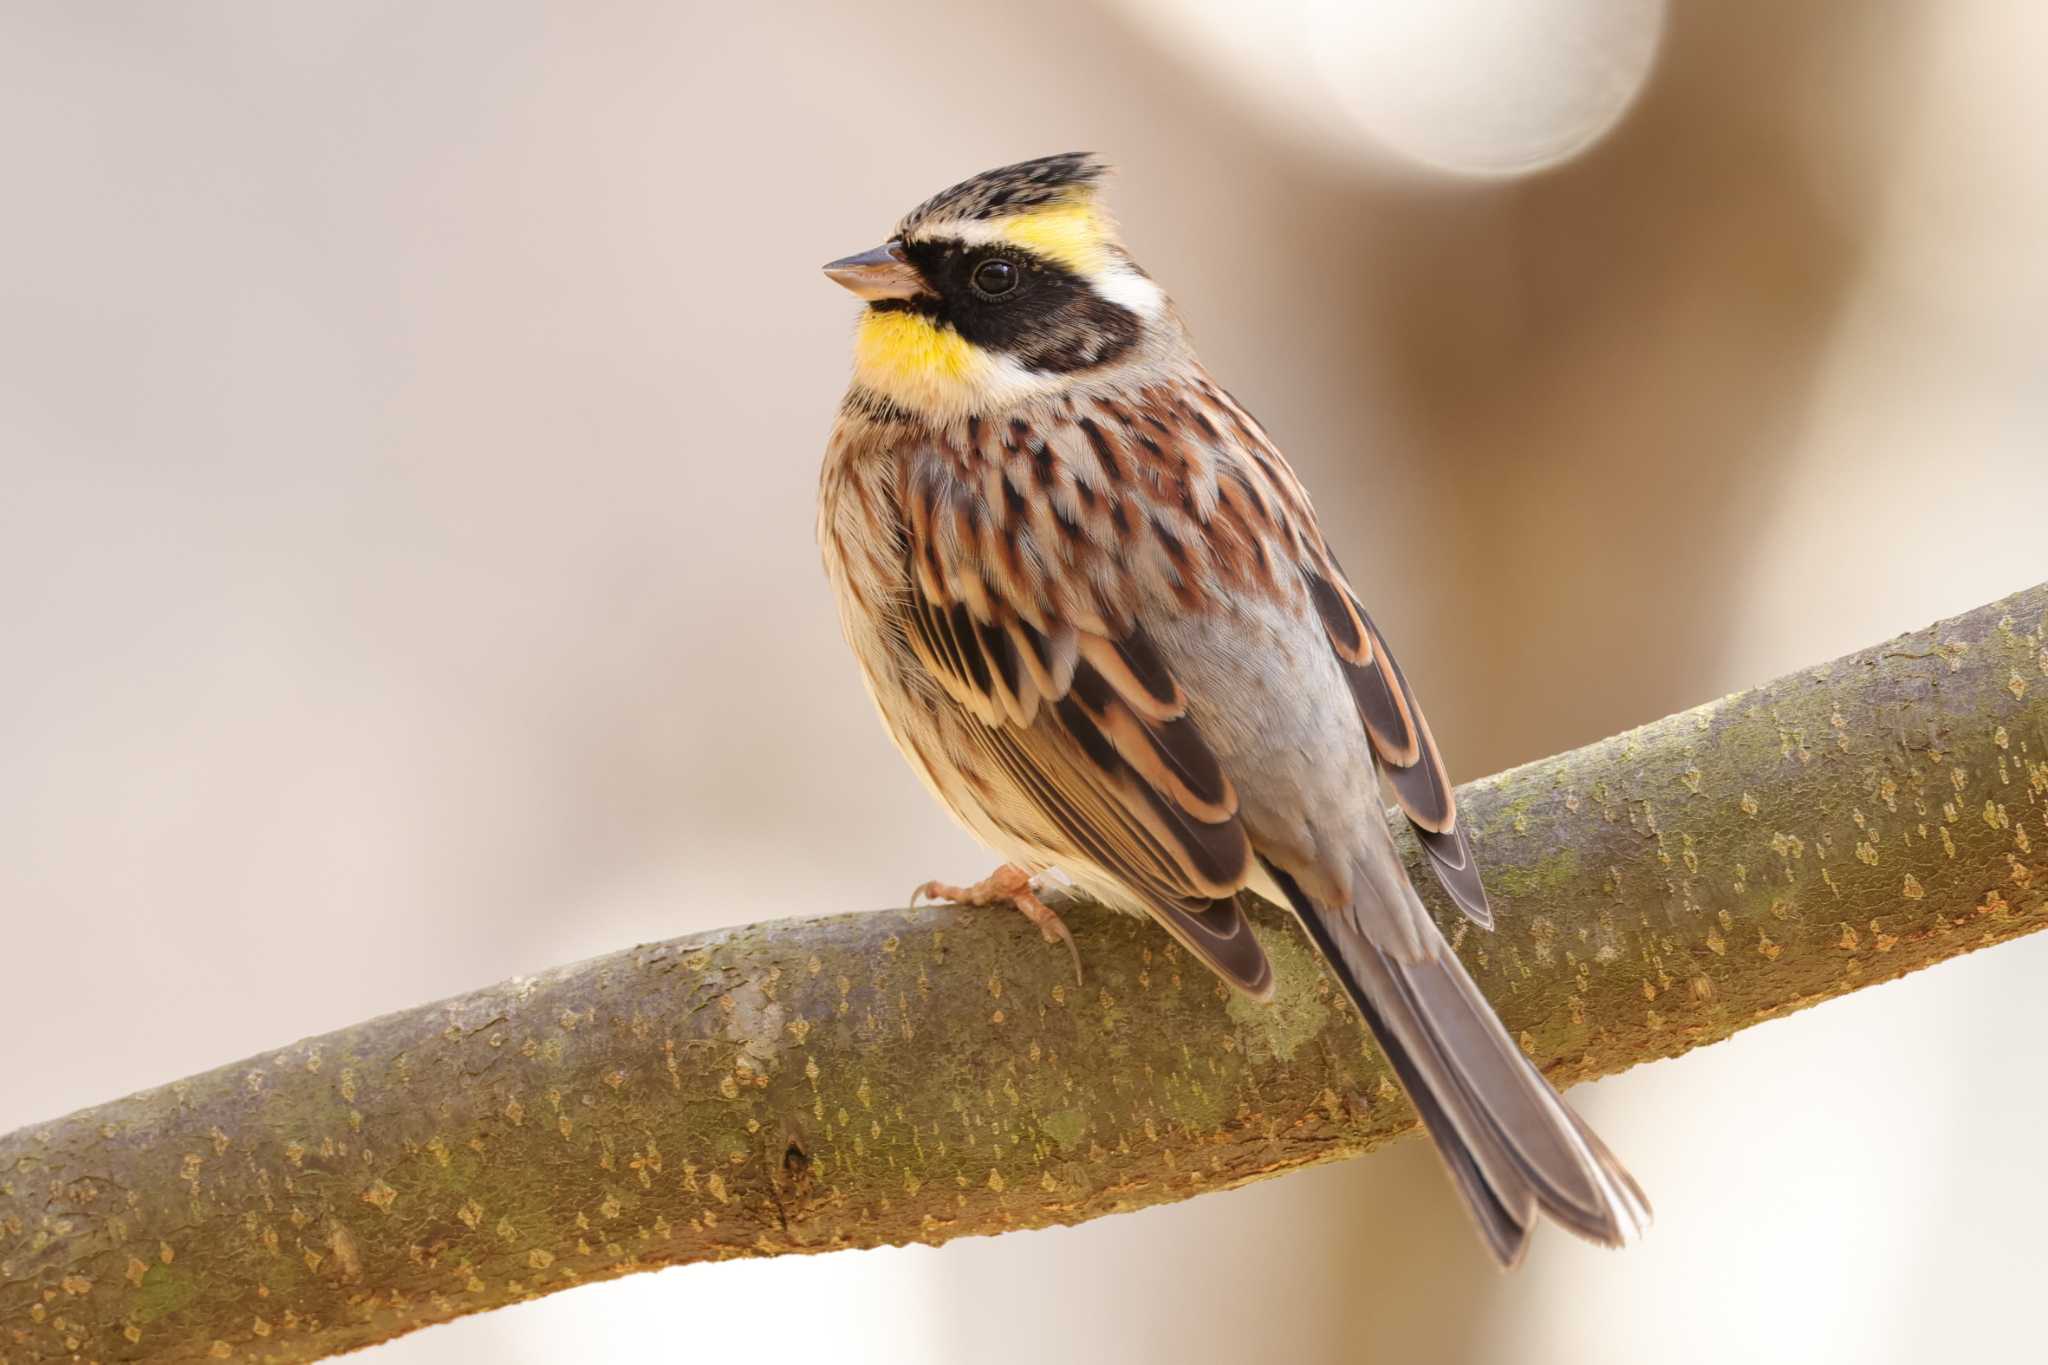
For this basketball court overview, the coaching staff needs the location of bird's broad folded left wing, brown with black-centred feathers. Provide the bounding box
[899,439,1272,997]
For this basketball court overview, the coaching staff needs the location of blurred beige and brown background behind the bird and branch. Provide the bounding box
[0,0,2048,1365]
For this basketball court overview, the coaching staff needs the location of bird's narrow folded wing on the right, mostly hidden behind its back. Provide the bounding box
[1303,551,1493,929]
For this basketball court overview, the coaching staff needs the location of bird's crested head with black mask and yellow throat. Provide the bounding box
[825,151,1178,420]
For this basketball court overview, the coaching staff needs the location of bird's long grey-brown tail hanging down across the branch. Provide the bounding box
[1268,864,1651,1267]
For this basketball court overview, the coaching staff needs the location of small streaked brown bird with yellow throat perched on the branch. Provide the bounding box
[817,153,1651,1267]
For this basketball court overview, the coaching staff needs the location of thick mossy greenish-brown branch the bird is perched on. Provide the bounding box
[0,585,2048,1365]
